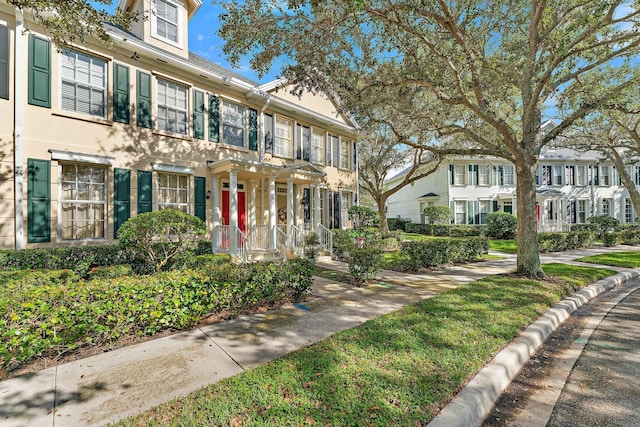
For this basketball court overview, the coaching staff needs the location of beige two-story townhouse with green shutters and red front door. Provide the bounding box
[0,0,358,251]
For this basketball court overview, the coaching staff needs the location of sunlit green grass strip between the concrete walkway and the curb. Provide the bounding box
[119,264,614,427]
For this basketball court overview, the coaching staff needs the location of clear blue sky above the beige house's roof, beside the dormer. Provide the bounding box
[96,0,280,83]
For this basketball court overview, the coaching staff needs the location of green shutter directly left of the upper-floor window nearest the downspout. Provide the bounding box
[29,34,51,108]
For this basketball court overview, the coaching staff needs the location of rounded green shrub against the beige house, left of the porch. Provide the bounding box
[118,209,206,272]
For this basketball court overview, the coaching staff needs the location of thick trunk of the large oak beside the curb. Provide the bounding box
[516,156,545,279]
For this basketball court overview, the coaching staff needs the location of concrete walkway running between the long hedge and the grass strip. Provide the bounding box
[0,248,629,427]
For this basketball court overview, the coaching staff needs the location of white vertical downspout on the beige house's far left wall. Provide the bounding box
[13,8,25,249]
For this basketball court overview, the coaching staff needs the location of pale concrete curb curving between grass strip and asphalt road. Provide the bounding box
[427,269,640,427]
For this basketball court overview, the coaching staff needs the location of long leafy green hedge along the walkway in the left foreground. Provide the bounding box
[0,259,313,369]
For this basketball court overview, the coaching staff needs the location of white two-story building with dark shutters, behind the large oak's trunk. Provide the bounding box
[387,148,640,231]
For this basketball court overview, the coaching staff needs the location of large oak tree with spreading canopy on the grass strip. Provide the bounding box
[219,0,640,277]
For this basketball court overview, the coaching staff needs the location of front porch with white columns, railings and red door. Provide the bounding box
[208,159,340,262]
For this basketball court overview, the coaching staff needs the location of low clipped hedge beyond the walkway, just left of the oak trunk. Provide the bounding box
[402,236,489,271]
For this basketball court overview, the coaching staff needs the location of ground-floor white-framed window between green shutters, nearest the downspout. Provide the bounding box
[60,164,107,240]
